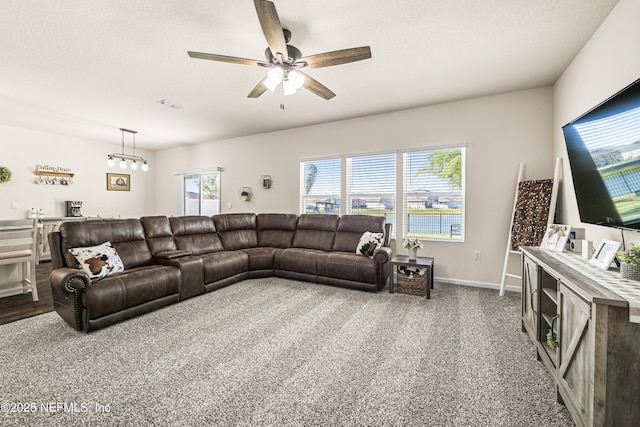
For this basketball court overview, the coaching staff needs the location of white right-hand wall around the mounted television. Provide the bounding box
[553,0,640,245]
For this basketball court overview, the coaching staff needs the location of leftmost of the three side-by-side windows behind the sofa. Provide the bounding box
[300,158,342,214]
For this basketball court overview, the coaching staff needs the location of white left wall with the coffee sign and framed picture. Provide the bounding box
[0,125,155,219]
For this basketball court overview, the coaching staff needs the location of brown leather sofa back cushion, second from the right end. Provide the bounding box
[292,214,340,252]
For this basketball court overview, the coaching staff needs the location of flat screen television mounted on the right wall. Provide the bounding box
[562,79,640,230]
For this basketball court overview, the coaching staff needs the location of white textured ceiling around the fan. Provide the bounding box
[0,0,618,150]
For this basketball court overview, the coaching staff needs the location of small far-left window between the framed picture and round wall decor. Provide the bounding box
[183,172,220,216]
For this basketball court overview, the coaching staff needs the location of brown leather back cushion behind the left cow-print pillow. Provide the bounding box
[60,219,153,270]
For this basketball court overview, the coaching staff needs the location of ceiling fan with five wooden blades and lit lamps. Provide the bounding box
[187,0,371,100]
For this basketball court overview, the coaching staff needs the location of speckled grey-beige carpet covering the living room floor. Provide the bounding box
[0,278,574,427]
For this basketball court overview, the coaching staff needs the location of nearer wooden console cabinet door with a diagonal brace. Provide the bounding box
[557,282,595,426]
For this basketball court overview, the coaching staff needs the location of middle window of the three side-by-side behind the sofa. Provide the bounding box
[346,153,396,224]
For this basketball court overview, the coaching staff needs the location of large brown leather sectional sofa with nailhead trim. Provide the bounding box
[49,213,391,332]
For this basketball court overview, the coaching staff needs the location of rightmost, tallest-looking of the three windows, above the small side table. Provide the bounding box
[403,147,465,241]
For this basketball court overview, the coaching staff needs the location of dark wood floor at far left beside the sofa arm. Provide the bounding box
[0,262,53,325]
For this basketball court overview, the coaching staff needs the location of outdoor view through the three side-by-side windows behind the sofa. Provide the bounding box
[301,147,464,241]
